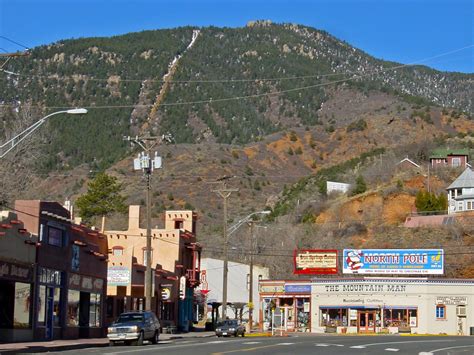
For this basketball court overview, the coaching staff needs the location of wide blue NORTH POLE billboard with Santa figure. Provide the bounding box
[342,249,444,275]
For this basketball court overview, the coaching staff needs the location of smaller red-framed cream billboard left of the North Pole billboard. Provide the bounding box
[294,250,337,275]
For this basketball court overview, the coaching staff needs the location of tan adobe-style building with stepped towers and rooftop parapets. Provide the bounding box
[104,206,201,331]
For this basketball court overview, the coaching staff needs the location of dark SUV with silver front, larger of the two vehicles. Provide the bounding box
[107,311,160,346]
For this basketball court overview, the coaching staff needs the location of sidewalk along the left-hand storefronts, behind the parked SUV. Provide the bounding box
[0,331,215,355]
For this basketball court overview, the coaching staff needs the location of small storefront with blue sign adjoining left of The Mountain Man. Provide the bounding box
[259,280,312,332]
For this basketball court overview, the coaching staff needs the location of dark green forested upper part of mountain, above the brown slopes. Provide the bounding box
[0,21,474,171]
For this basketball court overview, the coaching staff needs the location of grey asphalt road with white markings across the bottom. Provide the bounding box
[45,335,474,355]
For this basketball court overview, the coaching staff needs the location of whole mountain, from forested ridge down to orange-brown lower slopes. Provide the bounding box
[0,21,474,275]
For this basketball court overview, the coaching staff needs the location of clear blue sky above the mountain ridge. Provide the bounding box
[0,0,474,73]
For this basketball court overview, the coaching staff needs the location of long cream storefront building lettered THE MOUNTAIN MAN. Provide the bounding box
[311,277,474,335]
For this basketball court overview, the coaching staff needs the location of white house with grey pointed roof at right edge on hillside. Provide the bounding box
[446,168,474,214]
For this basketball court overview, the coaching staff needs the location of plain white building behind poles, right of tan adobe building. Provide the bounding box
[200,258,269,321]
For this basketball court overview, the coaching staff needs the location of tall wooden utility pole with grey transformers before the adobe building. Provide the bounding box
[123,135,171,310]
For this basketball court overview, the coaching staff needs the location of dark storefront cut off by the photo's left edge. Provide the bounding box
[0,211,37,343]
